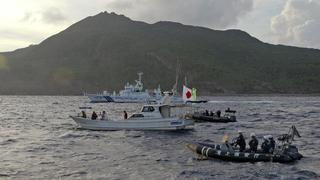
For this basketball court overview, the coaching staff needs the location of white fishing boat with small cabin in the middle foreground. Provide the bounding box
[71,105,194,130]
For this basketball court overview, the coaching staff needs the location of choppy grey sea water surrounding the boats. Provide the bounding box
[0,96,320,179]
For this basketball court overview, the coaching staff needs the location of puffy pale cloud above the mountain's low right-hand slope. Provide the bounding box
[271,0,320,48]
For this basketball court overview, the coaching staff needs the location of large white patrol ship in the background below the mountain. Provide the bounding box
[85,72,162,103]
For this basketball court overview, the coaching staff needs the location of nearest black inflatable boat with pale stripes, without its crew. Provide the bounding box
[187,143,302,163]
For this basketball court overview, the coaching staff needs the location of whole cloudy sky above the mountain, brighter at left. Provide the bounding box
[0,0,320,52]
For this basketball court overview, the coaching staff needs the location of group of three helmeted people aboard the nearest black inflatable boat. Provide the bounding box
[231,131,276,154]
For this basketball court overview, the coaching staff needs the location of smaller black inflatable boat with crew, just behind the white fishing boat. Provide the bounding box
[192,109,237,123]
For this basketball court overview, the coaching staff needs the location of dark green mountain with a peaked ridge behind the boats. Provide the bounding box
[0,12,320,95]
